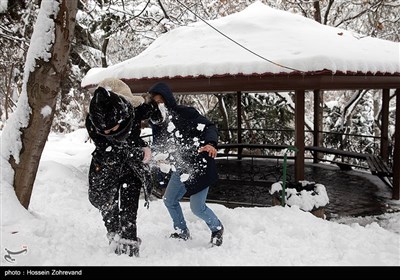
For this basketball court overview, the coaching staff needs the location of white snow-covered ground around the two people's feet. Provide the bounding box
[1,129,400,266]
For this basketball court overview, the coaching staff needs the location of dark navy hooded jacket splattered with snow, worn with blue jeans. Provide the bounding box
[149,82,218,196]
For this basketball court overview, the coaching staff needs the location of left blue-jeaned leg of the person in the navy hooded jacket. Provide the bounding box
[163,172,187,231]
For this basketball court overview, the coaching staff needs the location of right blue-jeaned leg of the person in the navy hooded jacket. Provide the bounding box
[190,188,222,232]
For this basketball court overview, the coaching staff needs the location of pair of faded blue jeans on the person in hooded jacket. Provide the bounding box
[163,172,222,232]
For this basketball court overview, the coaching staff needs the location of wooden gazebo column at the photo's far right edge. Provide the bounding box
[392,88,400,200]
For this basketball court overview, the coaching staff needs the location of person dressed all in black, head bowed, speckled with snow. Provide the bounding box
[86,79,161,256]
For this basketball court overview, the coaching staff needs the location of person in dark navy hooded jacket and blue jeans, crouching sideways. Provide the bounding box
[149,83,224,246]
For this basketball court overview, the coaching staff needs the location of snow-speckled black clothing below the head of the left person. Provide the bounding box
[86,101,161,241]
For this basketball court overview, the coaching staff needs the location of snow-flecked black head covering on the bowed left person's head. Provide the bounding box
[89,87,134,140]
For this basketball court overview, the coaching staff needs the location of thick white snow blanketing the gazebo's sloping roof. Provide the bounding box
[82,2,400,90]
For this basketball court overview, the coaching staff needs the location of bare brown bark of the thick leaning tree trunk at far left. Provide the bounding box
[10,0,78,209]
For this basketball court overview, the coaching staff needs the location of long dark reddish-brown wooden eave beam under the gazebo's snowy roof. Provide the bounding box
[101,73,400,94]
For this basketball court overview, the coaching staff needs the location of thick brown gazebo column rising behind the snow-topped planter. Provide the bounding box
[294,90,305,181]
